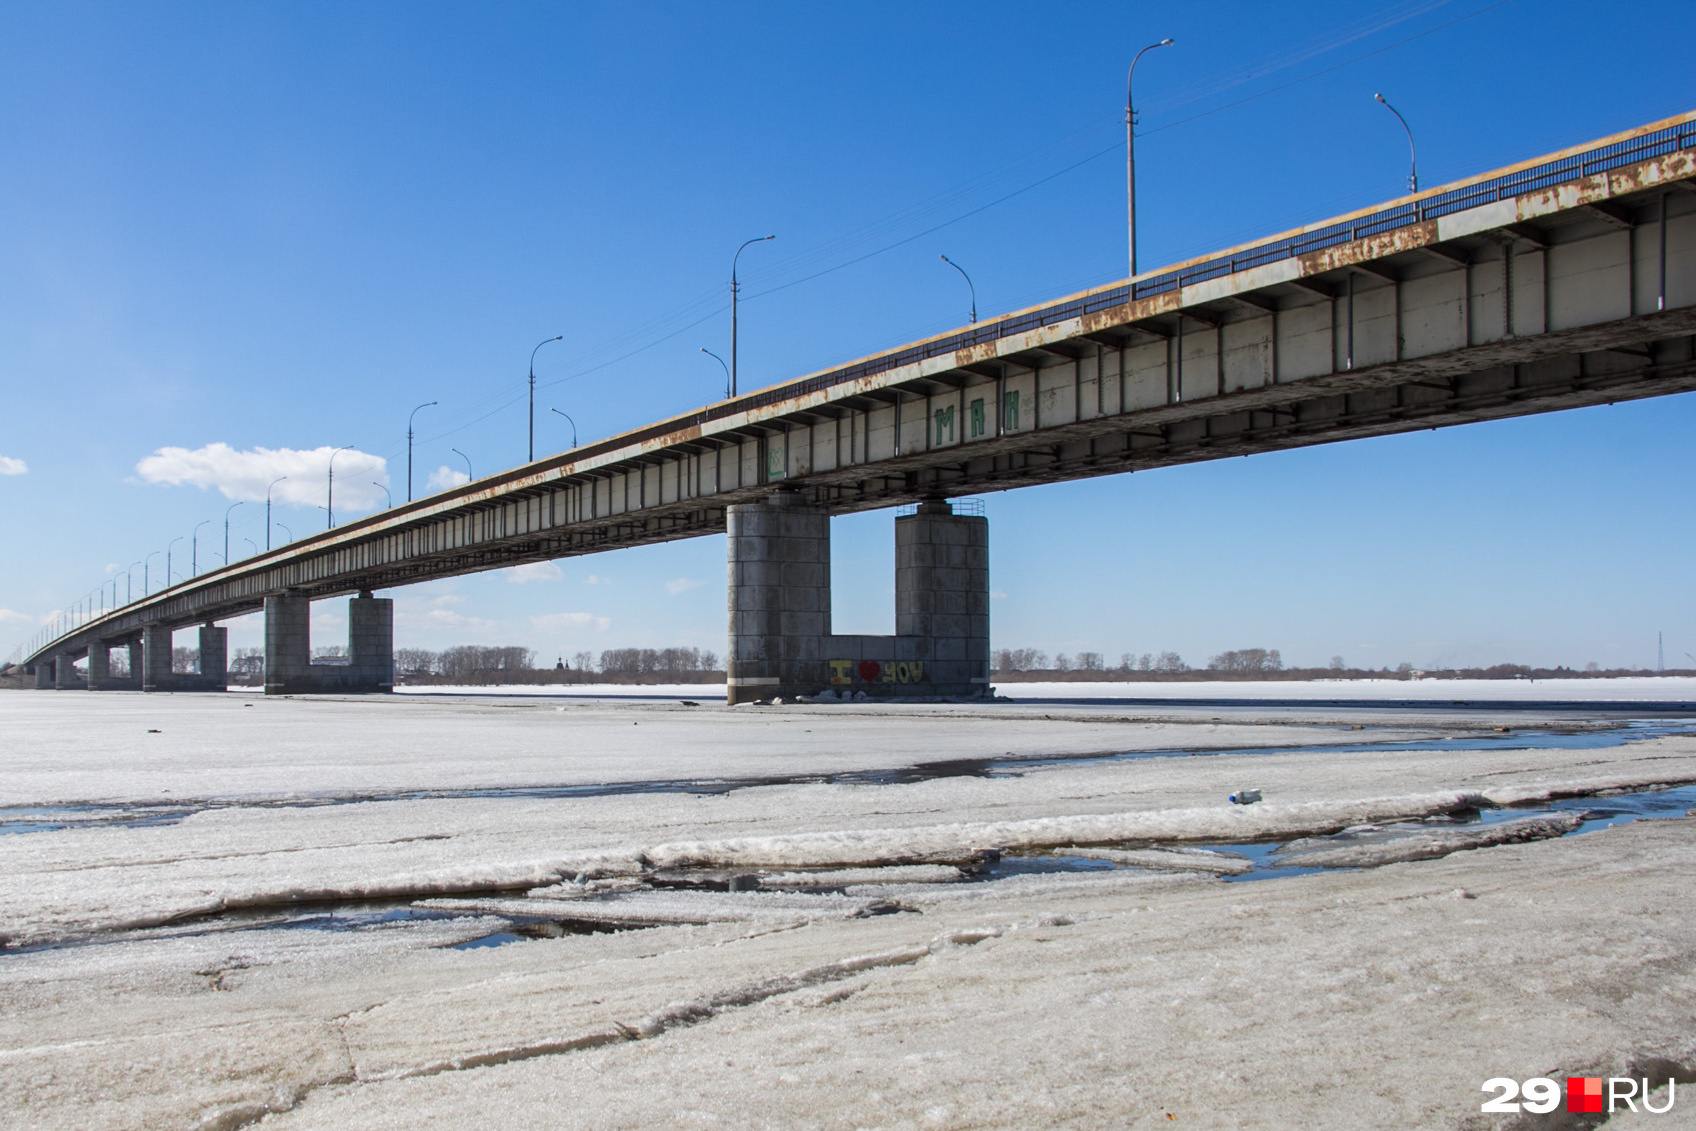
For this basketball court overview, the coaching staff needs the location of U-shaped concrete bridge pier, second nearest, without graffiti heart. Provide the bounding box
[265,592,395,695]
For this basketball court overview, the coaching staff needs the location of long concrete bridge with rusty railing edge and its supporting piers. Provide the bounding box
[25,114,1696,702]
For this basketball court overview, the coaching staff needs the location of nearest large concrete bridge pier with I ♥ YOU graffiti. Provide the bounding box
[726,490,989,704]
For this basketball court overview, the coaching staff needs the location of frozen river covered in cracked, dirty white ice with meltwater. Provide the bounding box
[0,682,1696,1128]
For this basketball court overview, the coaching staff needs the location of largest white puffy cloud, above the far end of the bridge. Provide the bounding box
[136,443,388,510]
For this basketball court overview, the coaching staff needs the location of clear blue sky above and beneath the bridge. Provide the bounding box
[0,0,1696,666]
